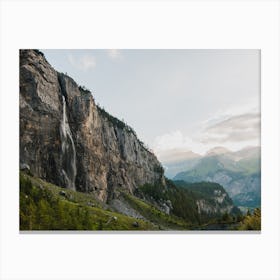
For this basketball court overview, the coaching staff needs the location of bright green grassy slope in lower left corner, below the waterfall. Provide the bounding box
[20,173,159,230]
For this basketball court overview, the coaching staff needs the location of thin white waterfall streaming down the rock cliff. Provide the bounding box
[60,96,77,190]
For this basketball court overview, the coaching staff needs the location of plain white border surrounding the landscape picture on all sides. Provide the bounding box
[0,0,280,280]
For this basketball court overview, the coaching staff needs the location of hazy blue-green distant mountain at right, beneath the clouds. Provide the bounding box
[174,147,261,207]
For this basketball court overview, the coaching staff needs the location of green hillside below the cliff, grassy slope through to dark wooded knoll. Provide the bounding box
[20,172,243,230]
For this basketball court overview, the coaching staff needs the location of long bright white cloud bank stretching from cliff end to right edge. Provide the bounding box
[152,112,261,156]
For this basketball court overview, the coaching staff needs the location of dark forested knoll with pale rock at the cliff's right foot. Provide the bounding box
[136,179,241,225]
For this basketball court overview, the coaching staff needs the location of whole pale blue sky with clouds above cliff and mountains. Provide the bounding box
[41,49,260,161]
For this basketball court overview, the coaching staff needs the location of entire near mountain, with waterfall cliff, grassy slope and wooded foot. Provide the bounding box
[19,50,243,230]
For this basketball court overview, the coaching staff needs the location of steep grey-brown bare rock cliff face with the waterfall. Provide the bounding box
[20,50,165,201]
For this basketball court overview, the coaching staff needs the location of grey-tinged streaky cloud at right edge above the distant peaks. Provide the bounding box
[201,113,261,144]
